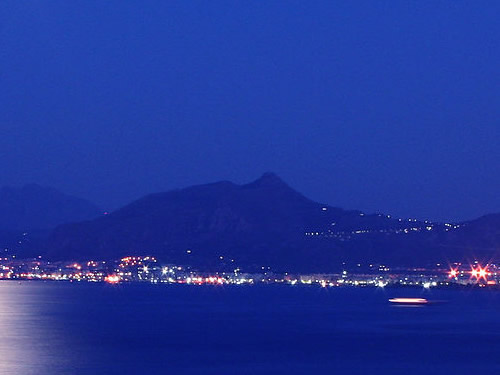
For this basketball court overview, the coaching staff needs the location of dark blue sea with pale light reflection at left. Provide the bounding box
[0,281,500,375]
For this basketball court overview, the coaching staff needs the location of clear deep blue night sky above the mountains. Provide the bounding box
[0,0,500,220]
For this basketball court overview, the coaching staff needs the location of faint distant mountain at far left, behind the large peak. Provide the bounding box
[0,184,101,232]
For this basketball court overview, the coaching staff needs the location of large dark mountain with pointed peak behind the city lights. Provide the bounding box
[47,173,500,271]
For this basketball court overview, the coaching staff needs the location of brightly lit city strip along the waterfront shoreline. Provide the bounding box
[0,256,500,289]
